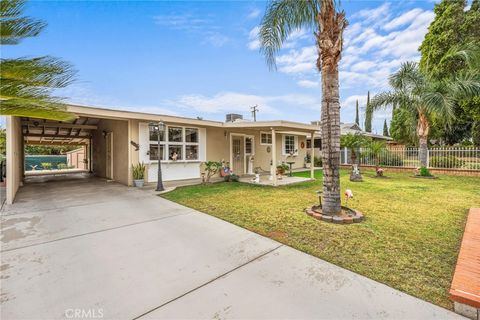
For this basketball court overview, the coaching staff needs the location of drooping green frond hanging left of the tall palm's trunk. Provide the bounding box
[259,0,318,69]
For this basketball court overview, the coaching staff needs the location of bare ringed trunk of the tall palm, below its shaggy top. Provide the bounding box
[322,68,341,215]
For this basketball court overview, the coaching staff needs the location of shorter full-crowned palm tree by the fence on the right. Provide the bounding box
[370,62,480,167]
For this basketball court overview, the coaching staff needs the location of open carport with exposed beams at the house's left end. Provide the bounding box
[6,106,135,204]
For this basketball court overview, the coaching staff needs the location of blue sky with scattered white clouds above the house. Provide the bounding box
[2,0,442,133]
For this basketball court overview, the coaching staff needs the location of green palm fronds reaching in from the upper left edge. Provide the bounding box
[0,0,76,120]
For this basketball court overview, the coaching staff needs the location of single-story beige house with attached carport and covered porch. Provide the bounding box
[7,105,318,203]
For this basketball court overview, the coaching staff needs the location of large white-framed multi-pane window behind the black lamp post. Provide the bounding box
[149,126,200,161]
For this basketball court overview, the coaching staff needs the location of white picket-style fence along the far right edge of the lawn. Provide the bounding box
[341,147,480,171]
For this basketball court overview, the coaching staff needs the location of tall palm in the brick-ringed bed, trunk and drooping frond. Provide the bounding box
[259,0,347,215]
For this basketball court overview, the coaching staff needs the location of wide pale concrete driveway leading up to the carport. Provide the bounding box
[1,177,460,319]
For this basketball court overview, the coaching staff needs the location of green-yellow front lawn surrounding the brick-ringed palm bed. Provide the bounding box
[163,171,480,309]
